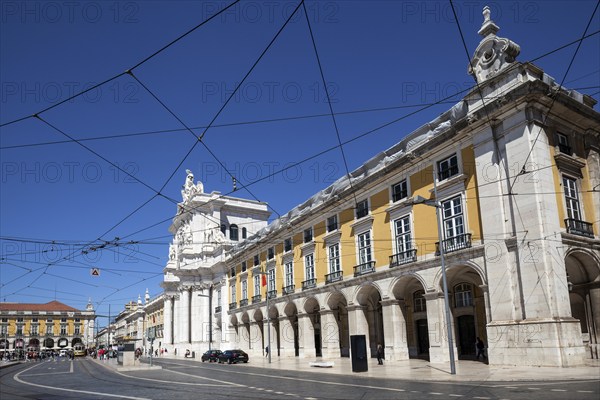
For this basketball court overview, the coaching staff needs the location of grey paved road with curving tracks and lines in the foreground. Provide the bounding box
[0,359,600,400]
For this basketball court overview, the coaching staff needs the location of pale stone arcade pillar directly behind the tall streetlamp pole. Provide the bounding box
[423,292,458,363]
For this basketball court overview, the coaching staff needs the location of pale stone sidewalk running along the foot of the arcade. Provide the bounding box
[156,356,600,382]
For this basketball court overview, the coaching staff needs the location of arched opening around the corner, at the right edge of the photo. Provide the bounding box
[565,249,600,359]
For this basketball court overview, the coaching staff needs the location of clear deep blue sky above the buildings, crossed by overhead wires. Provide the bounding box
[0,0,600,324]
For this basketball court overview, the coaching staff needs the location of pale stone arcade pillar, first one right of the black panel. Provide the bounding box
[381,300,408,360]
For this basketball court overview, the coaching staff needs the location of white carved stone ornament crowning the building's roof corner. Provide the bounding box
[469,6,521,83]
